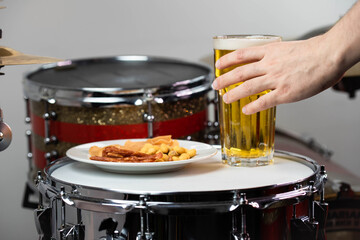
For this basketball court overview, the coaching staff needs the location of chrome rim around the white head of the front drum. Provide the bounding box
[44,150,320,196]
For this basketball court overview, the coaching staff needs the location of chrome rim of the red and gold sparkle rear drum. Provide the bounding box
[23,55,213,106]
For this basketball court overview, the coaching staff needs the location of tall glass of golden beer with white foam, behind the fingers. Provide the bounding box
[213,35,281,166]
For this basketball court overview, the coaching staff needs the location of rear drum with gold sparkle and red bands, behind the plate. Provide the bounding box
[24,56,211,175]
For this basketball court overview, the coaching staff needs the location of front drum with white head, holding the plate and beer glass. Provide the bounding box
[35,152,326,240]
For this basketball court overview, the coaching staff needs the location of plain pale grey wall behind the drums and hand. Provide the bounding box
[0,0,360,239]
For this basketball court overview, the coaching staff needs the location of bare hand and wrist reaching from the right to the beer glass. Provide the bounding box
[213,1,360,114]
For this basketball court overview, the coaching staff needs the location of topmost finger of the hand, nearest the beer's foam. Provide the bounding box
[215,46,264,69]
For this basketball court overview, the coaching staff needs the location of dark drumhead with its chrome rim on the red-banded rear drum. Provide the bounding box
[24,56,211,105]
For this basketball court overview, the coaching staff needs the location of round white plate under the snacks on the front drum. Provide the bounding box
[66,139,217,174]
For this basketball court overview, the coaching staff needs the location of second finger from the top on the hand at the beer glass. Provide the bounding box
[212,63,265,90]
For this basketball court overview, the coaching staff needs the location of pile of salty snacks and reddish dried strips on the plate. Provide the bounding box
[89,135,196,162]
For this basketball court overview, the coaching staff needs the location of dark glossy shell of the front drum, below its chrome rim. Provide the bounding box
[51,196,308,240]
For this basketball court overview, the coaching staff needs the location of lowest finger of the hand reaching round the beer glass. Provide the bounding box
[242,90,279,115]
